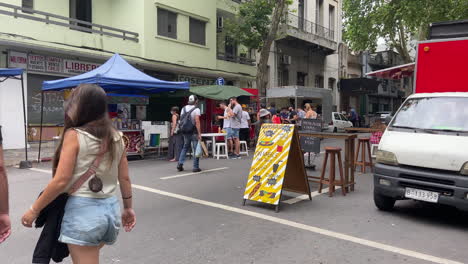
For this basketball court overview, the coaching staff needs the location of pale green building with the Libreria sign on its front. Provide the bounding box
[0,0,256,126]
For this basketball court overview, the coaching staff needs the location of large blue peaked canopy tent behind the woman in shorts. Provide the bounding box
[38,53,190,161]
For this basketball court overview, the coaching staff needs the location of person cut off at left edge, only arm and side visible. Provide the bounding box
[0,126,11,243]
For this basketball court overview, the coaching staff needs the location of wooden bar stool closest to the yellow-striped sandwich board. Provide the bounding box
[318,147,346,197]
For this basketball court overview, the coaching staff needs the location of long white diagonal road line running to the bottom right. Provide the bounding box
[132,184,462,264]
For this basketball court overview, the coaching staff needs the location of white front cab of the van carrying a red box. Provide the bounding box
[374,93,468,211]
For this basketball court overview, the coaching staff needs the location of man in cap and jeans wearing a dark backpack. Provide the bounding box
[177,95,201,172]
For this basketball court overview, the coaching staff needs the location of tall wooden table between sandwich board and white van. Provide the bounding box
[299,132,357,192]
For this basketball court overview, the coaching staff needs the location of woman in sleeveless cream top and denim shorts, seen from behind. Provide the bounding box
[21,84,136,264]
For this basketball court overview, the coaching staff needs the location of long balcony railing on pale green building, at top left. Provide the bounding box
[0,3,138,42]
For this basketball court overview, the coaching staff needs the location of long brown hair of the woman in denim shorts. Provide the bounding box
[53,84,116,176]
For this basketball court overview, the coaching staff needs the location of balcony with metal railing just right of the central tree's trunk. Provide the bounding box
[280,13,338,55]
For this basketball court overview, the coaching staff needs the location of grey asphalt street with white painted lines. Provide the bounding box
[0,137,468,264]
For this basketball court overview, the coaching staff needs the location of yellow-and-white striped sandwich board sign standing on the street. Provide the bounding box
[244,124,312,212]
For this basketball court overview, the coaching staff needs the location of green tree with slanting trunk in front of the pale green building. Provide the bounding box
[226,0,292,95]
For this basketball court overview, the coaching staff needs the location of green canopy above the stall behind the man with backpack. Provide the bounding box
[190,85,253,100]
